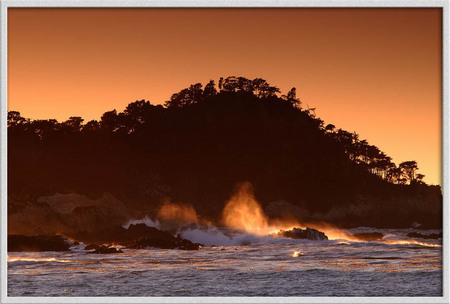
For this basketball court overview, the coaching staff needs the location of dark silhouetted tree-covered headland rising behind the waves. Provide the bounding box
[8,77,442,246]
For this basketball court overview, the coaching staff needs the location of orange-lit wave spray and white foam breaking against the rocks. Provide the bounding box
[118,182,441,247]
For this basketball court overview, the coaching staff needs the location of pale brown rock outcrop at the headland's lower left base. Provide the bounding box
[8,193,132,236]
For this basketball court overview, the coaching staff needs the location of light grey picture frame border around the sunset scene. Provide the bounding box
[0,0,450,303]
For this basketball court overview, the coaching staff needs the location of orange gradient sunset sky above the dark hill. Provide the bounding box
[8,8,442,184]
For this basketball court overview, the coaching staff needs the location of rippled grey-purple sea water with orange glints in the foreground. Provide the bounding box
[8,228,442,297]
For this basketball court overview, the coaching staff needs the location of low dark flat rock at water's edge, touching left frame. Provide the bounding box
[8,235,70,252]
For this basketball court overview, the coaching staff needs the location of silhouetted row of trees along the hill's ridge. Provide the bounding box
[8,76,425,184]
